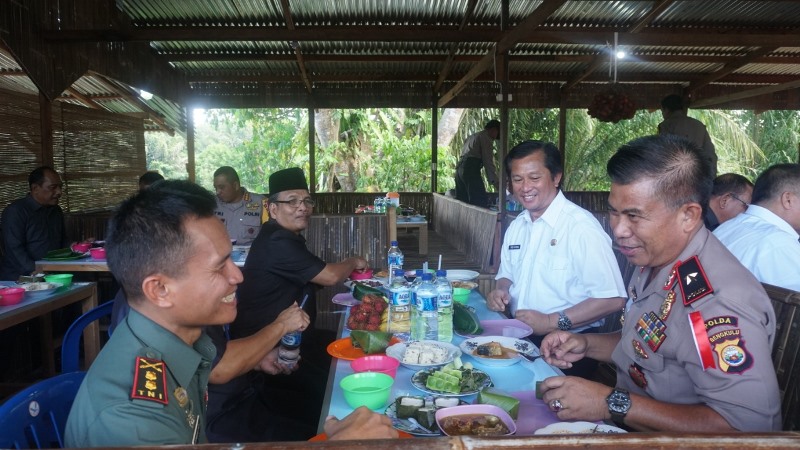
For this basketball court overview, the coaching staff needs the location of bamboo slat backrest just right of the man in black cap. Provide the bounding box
[305,213,388,331]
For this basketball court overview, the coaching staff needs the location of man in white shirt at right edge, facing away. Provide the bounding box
[714,164,800,291]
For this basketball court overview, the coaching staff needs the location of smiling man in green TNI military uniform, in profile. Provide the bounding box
[65,181,397,447]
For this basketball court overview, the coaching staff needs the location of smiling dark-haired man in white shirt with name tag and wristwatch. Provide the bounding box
[487,141,625,376]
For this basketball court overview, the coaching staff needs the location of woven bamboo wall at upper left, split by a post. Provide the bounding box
[0,87,147,220]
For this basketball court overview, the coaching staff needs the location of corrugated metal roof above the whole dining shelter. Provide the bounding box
[0,0,800,127]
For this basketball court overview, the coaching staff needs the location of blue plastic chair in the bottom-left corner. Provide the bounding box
[0,372,86,448]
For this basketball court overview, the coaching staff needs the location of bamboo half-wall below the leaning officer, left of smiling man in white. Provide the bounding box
[434,194,497,272]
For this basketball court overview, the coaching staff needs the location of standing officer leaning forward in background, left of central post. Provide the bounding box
[456,120,500,208]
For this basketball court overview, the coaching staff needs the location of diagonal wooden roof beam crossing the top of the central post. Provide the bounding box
[439,0,566,108]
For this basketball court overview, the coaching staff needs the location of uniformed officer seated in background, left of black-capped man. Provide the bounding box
[214,166,269,245]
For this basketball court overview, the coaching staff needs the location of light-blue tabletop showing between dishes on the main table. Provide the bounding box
[318,290,563,436]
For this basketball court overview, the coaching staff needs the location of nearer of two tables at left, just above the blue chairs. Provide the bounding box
[0,281,100,376]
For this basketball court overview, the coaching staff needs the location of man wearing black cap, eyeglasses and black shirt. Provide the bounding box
[210,167,367,441]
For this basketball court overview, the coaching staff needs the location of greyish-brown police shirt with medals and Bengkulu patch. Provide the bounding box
[612,228,781,431]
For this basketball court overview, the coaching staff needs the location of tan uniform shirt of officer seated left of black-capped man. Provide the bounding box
[214,188,267,245]
